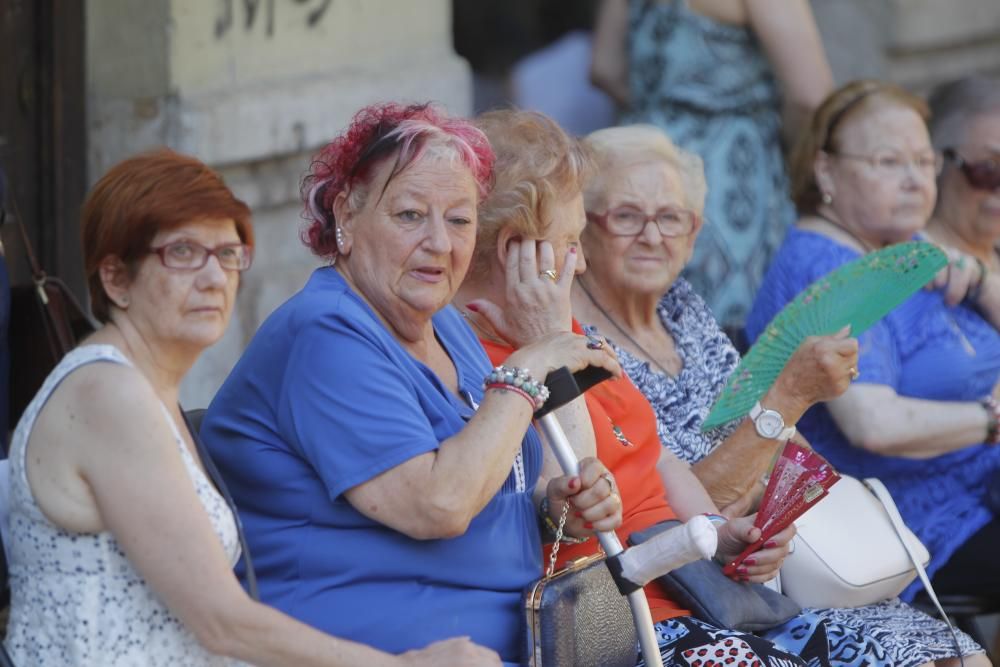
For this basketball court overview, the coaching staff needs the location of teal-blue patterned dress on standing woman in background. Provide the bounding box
[622,0,795,329]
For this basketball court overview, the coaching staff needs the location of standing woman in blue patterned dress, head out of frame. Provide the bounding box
[592,0,833,332]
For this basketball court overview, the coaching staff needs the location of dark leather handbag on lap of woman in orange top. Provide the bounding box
[628,521,802,632]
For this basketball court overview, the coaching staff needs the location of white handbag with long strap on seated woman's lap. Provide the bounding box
[781,475,930,608]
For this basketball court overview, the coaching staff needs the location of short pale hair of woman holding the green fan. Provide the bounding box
[584,124,708,215]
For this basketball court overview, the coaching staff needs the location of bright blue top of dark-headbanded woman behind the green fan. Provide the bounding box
[747,228,1000,599]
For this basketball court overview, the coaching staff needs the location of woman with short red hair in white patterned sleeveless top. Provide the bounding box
[0,150,484,667]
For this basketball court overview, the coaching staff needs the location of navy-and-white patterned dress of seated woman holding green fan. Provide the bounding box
[584,276,982,667]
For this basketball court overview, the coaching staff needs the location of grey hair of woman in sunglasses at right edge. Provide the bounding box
[928,75,1000,151]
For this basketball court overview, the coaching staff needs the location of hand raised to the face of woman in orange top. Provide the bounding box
[466,239,578,349]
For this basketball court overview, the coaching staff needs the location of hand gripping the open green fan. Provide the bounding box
[767,326,858,411]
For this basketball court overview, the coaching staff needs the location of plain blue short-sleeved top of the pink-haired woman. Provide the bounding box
[201,268,542,663]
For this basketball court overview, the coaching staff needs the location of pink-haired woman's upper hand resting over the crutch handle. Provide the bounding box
[504,332,623,382]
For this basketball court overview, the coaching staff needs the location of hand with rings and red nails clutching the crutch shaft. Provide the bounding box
[546,457,622,537]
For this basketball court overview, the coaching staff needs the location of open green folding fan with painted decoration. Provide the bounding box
[701,241,948,431]
